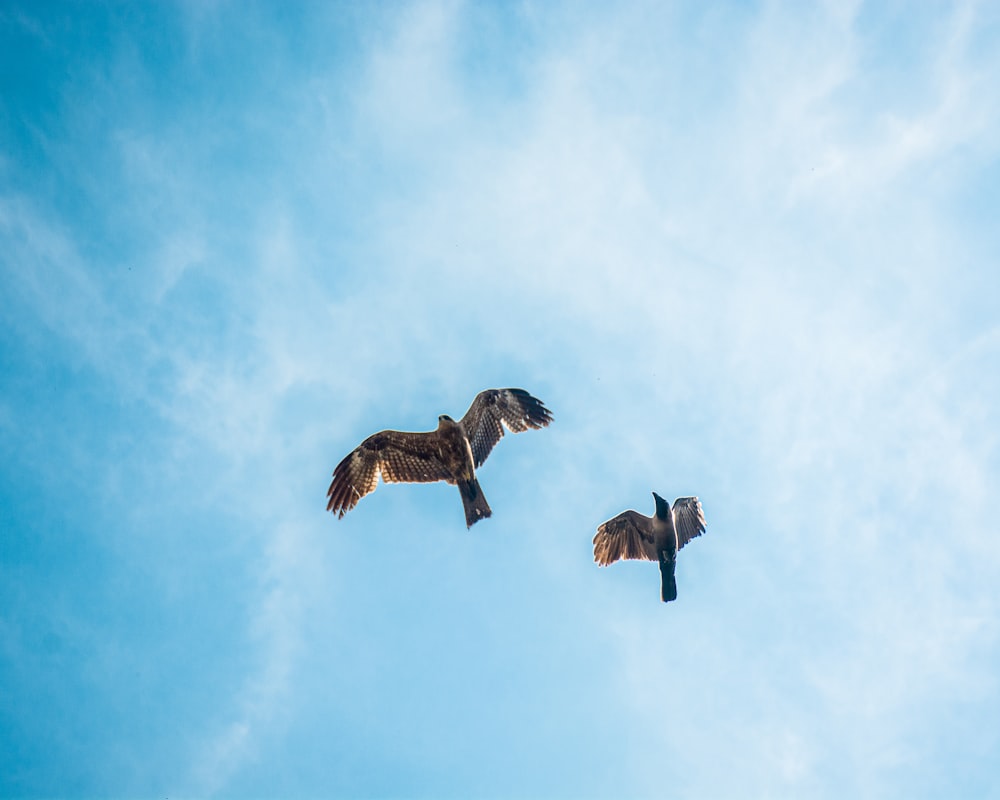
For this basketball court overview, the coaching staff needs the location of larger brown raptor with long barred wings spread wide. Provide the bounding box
[326,389,552,528]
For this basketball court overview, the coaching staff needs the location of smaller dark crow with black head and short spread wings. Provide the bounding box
[594,492,705,603]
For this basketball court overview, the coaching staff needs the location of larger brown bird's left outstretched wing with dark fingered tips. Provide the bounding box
[326,431,454,517]
